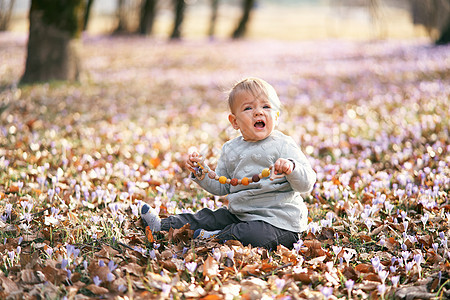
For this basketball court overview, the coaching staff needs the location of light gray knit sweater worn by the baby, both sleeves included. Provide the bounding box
[194,130,316,232]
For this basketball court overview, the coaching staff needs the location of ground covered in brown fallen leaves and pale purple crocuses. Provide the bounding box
[0,33,450,299]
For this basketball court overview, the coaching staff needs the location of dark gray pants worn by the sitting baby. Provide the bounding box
[161,207,299,250]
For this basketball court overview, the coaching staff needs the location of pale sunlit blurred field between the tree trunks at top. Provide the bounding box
[0,0,450,41]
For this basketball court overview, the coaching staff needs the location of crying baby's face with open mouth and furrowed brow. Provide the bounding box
[228,91,278,142]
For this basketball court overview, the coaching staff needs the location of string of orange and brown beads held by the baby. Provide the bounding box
[194,159,285,186]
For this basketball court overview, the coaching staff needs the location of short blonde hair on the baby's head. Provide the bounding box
[228,77,281,112]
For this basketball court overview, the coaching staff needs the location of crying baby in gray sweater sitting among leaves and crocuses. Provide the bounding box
[141,78,316,249]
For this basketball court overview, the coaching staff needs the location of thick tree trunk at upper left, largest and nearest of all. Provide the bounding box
[21,0,85,83]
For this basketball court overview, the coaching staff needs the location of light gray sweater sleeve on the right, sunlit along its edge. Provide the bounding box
[281,138,316,193]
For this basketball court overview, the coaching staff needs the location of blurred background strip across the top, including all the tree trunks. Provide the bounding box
[0,0,450,83]
